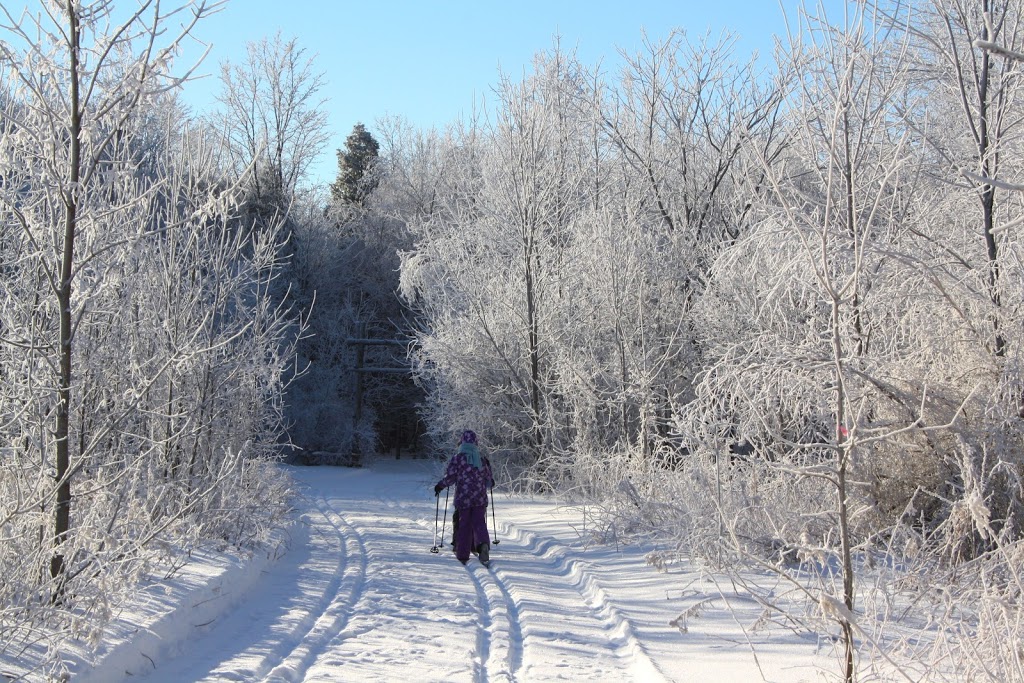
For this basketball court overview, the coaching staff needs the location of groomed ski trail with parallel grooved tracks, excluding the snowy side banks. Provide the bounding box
[138,461,665,683]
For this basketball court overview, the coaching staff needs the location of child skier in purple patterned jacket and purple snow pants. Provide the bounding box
[434,429,495,565]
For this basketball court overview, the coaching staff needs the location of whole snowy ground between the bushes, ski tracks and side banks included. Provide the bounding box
[84,461,820,683]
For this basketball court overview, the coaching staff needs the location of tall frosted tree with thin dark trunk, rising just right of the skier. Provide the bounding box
[402,48,587,475]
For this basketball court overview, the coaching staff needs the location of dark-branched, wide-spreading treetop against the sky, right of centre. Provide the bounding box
[602,31,783,245]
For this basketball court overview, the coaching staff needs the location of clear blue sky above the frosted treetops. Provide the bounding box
[176,0,842,180]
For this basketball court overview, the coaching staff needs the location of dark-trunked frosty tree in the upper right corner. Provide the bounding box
[880,0,1024,358]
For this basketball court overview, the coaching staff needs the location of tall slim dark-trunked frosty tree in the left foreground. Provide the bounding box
[3,3,220,601]
